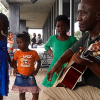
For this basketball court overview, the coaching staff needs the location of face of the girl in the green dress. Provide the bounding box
[56,21,68,35]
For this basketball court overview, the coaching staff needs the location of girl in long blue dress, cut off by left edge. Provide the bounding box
[0,13,11,100]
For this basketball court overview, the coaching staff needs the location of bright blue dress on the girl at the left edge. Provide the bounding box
[0,36,9,96]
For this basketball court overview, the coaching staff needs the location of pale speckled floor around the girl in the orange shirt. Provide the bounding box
[4,69,47,100]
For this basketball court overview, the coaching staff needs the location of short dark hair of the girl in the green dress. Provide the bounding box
[55,15,70,27]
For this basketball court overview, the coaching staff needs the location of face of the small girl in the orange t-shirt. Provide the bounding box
[17,37,28,51]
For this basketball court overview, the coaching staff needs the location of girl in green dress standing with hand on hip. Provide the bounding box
[42,15,77,87]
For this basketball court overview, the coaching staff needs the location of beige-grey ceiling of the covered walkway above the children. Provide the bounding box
[0,0,55,28]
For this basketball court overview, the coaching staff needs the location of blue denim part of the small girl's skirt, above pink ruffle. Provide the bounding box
[14,73,37,87]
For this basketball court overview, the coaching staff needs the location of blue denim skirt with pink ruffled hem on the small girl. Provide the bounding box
[12,73,41,93]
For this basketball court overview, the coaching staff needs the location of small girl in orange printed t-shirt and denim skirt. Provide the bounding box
[12,32,41,100]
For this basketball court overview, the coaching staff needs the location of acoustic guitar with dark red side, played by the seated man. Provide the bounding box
[53,41,100,89]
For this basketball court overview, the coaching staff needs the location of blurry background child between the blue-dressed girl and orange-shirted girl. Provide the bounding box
[7,31,14,75]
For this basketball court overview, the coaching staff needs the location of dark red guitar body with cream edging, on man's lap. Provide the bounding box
[53,62,87,89]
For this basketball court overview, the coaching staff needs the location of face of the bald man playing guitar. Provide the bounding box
[77,0,97,32]
